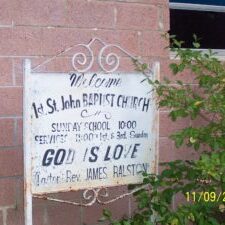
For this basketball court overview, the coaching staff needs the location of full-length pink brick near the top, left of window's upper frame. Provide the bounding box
[116,4,158,30]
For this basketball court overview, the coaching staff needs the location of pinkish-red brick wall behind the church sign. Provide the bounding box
[0,0,169,225]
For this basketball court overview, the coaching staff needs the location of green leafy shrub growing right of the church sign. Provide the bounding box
[103,36,225,225]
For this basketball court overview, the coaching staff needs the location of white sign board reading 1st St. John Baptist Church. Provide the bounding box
[24,64,157,194]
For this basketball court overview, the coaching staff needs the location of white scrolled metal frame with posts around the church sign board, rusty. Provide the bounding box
[23,38,160,225]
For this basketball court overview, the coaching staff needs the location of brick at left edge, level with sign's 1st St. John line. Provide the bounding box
[0,87,22,116]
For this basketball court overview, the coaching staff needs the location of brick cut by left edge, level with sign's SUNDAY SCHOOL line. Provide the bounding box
[0,119,15,147]
